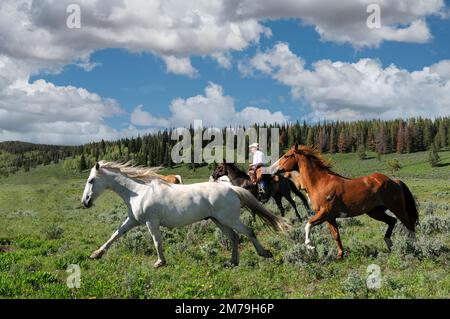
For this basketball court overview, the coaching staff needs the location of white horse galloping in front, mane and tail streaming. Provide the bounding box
[82,161,289,267]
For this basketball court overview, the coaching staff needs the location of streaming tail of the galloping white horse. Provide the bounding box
[230,186,291,232]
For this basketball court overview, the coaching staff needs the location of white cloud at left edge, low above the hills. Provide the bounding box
[0,55,133,144]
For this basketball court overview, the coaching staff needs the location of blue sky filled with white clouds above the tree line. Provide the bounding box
[0,0,450,144]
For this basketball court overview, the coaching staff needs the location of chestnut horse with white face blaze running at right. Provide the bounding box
[270,144,419,257]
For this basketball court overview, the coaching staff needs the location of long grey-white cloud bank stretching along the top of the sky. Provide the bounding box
[0,0,445,76]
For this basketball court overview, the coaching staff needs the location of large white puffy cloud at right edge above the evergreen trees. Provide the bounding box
[240,43,450,120]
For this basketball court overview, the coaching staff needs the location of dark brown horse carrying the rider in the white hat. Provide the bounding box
[212,163,310,219]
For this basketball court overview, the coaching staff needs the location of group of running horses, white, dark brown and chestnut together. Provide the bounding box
[82,144,418,267]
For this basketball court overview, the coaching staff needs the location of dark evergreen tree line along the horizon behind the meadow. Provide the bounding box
[0,117,450,176]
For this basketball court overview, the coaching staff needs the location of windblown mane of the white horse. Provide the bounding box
[99,161,165,183]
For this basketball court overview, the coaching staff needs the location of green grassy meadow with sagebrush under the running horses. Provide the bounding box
[0,152,450,298]
